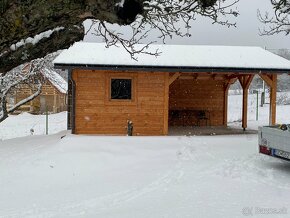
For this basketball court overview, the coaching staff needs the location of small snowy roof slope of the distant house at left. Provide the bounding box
[41,68,68,94]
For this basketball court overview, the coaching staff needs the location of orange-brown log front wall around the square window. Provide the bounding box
[73,70,168,135]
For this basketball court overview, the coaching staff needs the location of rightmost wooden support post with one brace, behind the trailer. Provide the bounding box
[260,74,277,125]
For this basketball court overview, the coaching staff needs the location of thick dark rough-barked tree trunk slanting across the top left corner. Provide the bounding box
[0,0,142,73]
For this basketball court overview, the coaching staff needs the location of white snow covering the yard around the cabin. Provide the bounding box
[0,93,290,218]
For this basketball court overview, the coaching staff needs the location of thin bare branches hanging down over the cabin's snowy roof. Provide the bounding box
[90,0,238,60]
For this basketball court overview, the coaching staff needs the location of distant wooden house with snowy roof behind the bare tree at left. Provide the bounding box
[10,68,67,114]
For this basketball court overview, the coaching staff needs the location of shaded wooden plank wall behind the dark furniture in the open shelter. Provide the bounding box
[169,74,227,126]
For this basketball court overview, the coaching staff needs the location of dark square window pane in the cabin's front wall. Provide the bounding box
[111,79,132,99]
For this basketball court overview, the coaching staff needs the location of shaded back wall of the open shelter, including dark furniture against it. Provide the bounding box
[169,74,226,126]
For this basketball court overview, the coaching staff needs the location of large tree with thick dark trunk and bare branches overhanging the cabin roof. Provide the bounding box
[0,0,238,73]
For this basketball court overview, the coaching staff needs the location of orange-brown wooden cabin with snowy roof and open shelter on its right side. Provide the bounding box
[54,42,290,135]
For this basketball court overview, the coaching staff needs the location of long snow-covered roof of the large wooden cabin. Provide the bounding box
[54,42,290,71]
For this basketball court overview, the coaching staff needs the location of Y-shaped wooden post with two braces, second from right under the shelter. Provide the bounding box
[238,75,254,130]
